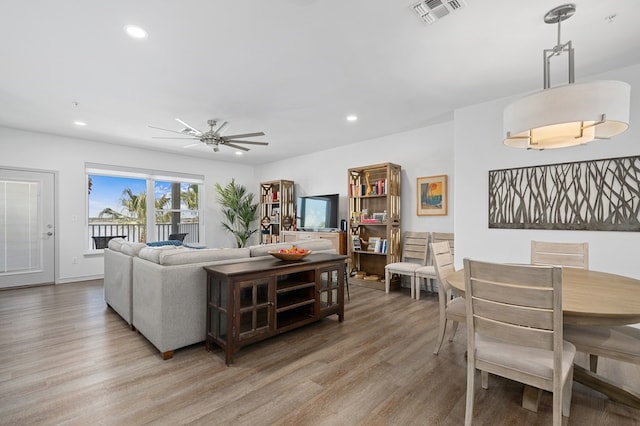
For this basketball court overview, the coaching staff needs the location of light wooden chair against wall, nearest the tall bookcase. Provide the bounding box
[384,232,431,299]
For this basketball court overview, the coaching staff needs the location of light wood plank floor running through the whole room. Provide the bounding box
[0,281,640,426]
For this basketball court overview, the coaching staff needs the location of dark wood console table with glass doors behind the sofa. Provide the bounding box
[204,253,347,365]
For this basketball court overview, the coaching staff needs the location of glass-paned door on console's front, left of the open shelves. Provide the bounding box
[238,278,270,340]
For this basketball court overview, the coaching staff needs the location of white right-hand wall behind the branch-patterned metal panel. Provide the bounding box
[454,61,640,278]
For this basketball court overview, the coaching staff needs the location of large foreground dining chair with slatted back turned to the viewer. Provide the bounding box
[464,259,576,426]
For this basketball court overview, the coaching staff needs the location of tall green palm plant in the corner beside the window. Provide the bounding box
[215,179,258,247]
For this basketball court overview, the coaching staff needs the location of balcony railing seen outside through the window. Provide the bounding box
[89,222,200,248]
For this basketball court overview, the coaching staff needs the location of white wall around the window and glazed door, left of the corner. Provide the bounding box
[0,127,256,282]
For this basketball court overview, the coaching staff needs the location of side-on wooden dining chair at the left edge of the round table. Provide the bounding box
[429,241,466,355]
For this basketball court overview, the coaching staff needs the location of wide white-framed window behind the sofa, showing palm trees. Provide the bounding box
[86,164,204,250]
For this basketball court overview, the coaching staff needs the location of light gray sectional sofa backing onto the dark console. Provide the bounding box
[104,239,335,359]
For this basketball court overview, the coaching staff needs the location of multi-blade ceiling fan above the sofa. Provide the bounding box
[149,118,269,152]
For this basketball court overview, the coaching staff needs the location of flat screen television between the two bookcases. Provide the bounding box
[296,194,339,231]
